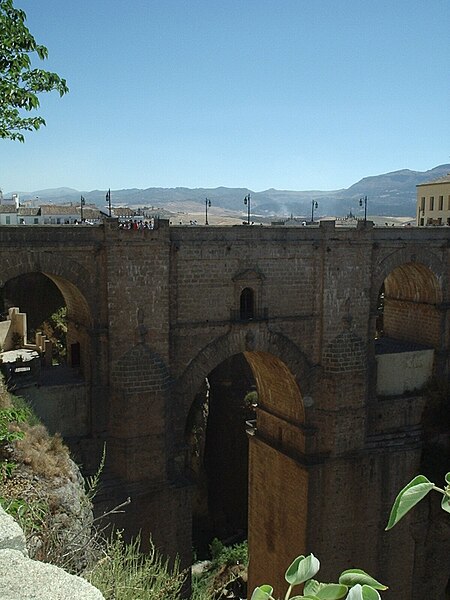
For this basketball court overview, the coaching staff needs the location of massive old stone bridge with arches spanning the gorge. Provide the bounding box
[0,220,450,600]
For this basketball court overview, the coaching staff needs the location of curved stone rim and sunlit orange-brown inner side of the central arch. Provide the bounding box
[176,327,311,595]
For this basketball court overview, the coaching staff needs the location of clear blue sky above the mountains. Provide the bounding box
[0,0,450,192]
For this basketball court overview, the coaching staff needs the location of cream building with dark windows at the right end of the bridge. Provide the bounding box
[416,173,450,227]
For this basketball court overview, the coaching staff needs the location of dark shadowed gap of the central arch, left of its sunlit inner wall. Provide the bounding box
[187,354,257,558]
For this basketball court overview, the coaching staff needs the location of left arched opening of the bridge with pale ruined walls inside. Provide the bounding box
[0,272,91,386]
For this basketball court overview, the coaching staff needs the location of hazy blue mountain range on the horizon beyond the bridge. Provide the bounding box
[6,164,450,218]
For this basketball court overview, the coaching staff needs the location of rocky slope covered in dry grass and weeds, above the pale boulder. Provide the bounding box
[0,381,97,573]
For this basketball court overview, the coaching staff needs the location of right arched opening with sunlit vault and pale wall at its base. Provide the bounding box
[375,263,442,396]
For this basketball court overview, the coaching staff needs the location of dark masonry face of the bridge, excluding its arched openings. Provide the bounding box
[0,221,450,600]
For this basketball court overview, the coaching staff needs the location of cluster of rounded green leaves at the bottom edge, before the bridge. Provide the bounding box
[251,554,387,600]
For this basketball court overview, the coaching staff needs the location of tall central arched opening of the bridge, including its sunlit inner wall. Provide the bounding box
[186,351,308,595]
